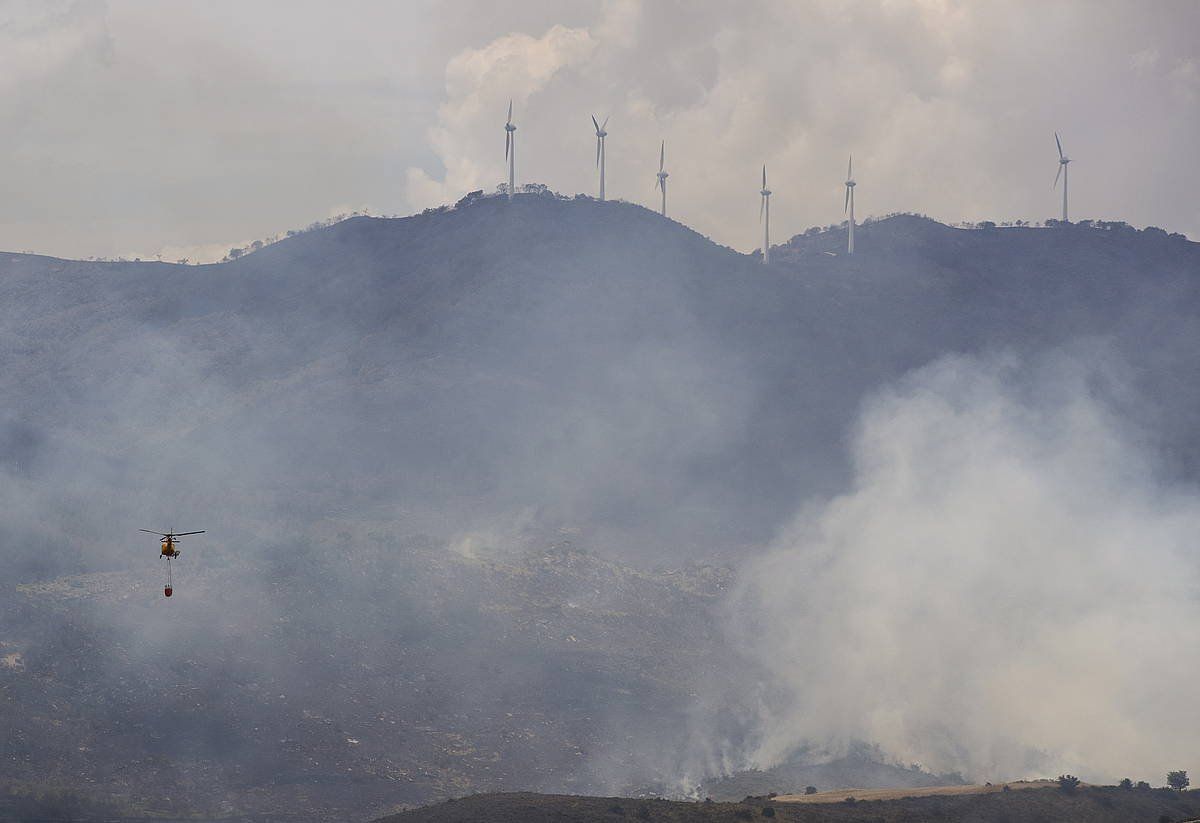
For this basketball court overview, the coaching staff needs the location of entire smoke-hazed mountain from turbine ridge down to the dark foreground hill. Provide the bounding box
[0,196,1200,816]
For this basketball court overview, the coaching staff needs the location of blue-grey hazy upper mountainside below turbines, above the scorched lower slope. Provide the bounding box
[0,197,1200,572]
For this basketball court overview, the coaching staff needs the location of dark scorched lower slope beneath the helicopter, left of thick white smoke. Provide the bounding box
[0,544,734,819]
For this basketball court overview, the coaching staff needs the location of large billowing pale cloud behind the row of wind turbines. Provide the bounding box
[408,0,1200,244]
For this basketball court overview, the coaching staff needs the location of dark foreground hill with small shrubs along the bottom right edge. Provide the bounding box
[383,787,1200,823]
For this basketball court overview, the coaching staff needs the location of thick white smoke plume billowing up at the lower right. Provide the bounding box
[732,354,1200,780]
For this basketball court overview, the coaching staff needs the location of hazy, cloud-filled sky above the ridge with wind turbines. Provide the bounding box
[0,0,1200,259]
